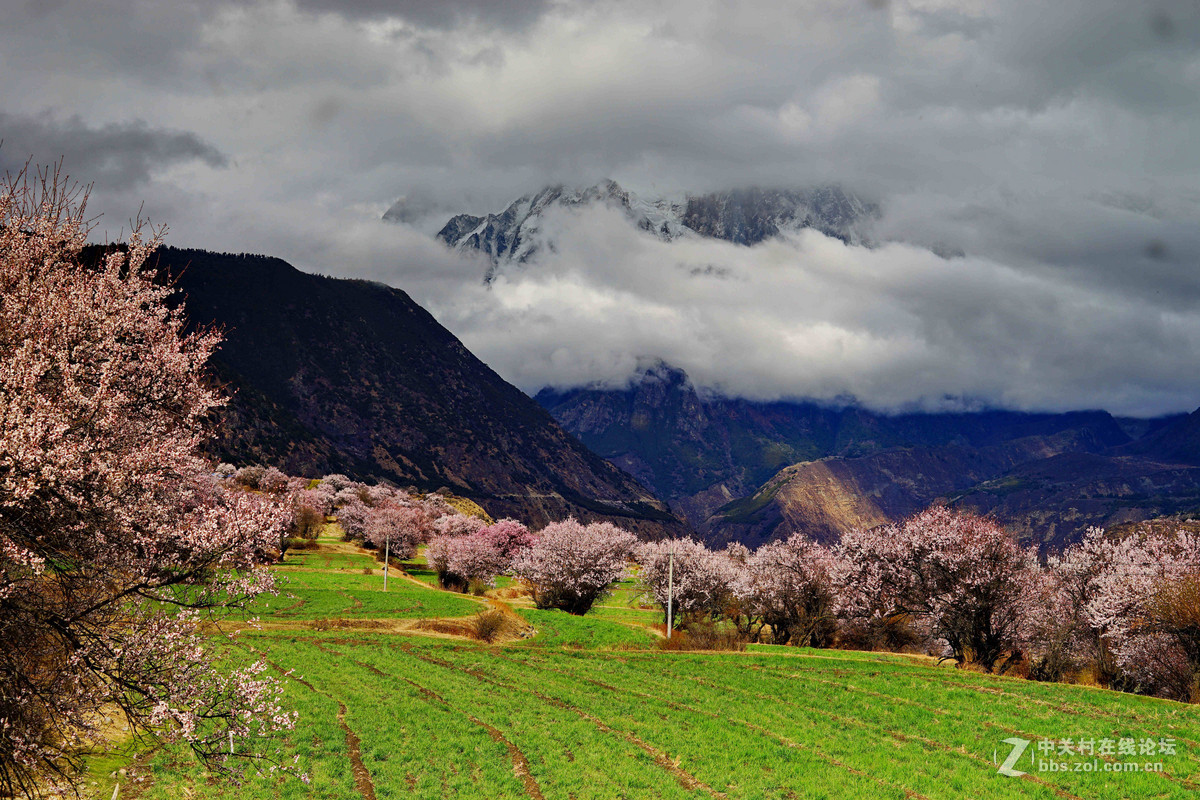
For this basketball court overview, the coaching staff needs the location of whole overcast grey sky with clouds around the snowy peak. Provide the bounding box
[0,0,1200,415]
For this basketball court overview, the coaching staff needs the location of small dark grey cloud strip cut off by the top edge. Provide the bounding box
[296,0,547,29]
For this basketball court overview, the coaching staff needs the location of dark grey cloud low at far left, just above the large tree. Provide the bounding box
[0,112,228,191]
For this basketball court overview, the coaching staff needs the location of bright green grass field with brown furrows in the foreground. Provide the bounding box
[97,532,1200,800]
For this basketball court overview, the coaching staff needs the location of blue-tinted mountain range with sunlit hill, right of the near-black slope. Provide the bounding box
[538,363,1200,547]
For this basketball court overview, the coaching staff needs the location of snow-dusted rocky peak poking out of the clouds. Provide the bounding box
[427,180,878,282]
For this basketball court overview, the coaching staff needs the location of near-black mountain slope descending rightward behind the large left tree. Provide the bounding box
[129,248,680,535]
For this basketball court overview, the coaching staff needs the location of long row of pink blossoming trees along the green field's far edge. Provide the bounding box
[314,462,1200,699]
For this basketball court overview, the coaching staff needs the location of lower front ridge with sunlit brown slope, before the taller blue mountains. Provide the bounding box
[706,427,1166,549]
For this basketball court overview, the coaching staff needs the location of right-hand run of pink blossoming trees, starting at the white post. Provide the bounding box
[635,506,1200,700]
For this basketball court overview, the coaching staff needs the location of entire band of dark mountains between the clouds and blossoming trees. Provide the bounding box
[75,242,1200,548]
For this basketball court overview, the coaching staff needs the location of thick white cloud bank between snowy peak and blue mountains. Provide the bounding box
[412,207,1200,414]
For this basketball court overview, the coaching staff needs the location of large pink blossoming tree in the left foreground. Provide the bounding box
[0,167,292,795]
